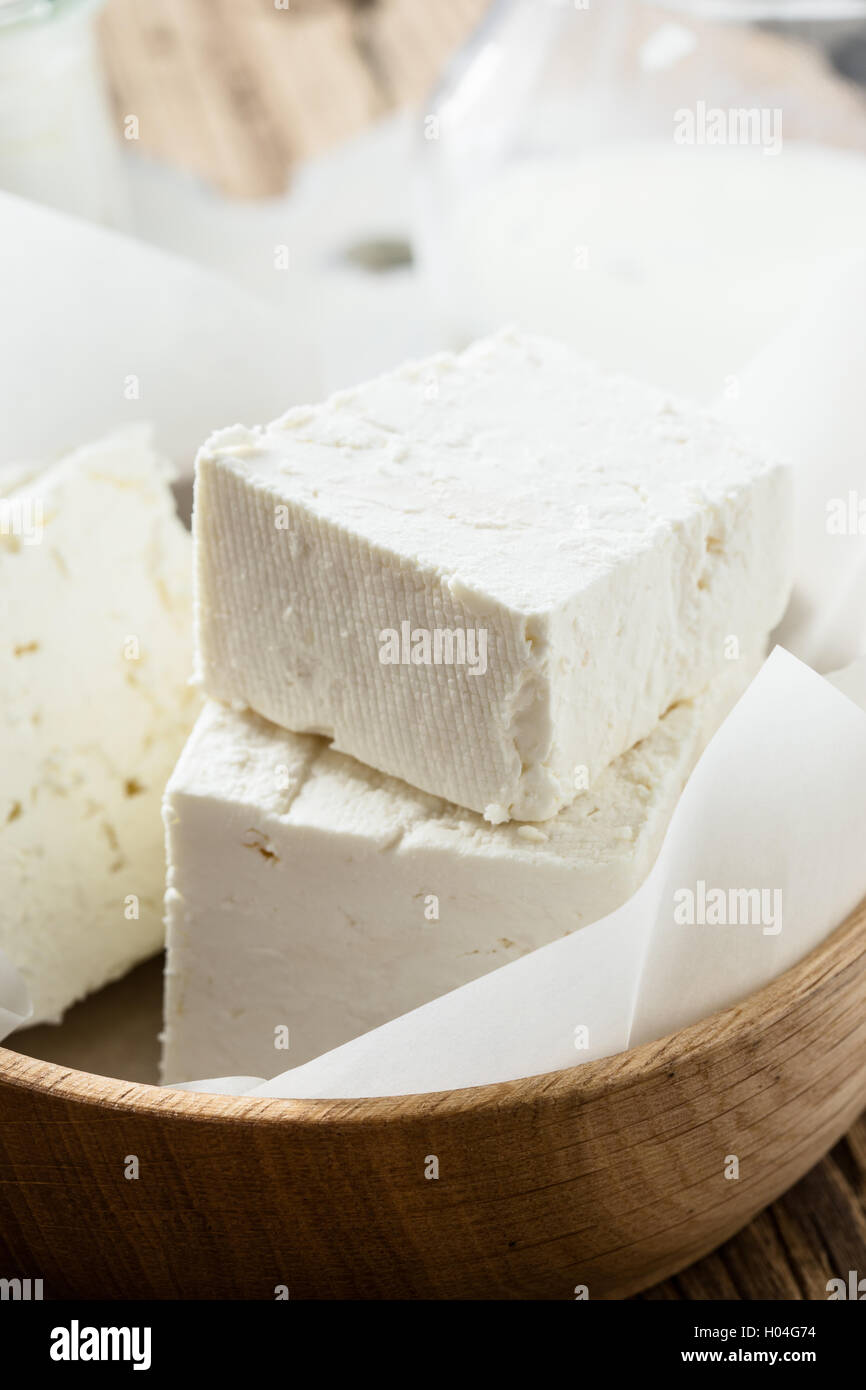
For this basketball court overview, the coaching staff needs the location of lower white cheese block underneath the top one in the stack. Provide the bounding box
[163,659,756,1081]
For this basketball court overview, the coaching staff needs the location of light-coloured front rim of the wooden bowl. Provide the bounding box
[0,899,866,1126]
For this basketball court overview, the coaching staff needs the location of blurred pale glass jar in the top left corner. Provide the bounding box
[0,0,125,225]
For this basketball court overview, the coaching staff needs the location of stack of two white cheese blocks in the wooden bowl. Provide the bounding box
[164,334,791,1080]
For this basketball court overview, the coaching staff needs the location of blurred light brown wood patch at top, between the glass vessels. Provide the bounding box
[101,0,487,197]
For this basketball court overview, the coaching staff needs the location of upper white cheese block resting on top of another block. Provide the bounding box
[193,334,791,823]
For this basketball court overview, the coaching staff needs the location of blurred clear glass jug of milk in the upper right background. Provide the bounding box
[416,0,866,399]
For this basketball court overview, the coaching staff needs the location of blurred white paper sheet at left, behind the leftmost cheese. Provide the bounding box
[0,193,316,471]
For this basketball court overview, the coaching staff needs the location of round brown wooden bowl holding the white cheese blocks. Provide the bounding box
[0,904,866,1298]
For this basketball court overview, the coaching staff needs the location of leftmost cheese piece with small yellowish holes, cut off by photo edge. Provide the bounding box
[0,430,199,1022]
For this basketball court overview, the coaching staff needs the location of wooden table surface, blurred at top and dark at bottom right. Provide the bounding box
[81,0,866,1300]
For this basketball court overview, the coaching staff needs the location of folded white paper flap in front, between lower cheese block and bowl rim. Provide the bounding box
[240,648,866,1098]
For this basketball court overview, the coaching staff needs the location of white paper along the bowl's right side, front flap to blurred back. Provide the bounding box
[167,254,866,1098]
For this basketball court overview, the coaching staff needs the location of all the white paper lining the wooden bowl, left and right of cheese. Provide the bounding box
[0,195,866,1098]
